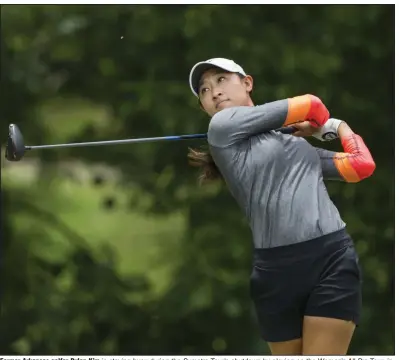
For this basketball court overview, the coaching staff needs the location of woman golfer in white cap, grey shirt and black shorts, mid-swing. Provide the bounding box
[189,58,375,355]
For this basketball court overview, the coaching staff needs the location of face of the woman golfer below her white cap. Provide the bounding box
[198,68,253,117]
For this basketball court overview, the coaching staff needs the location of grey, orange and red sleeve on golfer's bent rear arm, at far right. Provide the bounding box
[315,134,376,183]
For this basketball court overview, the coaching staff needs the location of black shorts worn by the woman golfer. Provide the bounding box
[250,230,362,342]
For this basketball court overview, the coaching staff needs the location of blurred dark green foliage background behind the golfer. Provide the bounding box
[0,5,394,355]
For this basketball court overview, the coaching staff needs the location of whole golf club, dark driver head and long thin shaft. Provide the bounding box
[5,124,296,161]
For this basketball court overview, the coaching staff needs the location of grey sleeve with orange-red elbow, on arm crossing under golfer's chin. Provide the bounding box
[208,95,329,147]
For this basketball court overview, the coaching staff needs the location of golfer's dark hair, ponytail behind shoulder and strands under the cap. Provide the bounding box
[187,70,252,185]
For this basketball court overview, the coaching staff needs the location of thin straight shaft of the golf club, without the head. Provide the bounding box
[25,127,295,150]
